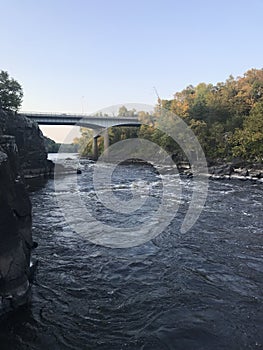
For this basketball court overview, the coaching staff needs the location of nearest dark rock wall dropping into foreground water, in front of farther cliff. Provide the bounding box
[0,135,33,314]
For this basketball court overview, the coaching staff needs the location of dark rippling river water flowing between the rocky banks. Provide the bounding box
[0,159,263,350]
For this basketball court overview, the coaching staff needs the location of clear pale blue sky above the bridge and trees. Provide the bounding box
[0,0,263,140]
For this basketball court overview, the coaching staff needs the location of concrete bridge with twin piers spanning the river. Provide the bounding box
[19,112,141,159]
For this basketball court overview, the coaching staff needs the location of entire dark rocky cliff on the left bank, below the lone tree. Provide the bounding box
[0,111,54,315]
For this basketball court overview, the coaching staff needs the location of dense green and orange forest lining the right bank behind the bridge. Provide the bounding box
[75,69,263,162]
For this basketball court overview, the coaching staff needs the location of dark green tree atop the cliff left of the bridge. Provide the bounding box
[0,70,23,112]
